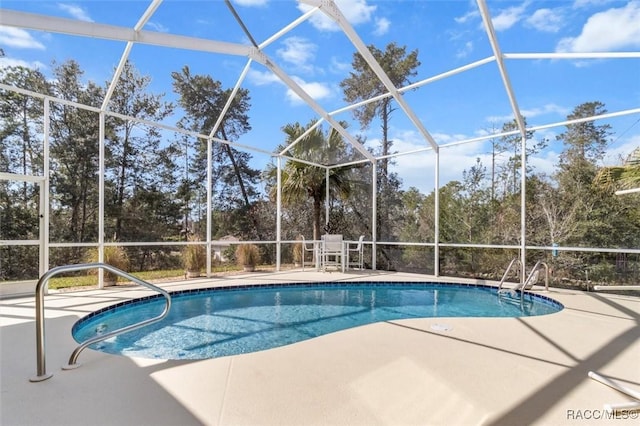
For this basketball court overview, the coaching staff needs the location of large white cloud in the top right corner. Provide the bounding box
[556,1,640,52]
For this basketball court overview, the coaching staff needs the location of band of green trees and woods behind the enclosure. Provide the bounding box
[0,50,640,283]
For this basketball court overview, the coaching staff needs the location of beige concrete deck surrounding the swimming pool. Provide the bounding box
[0,271,640,426]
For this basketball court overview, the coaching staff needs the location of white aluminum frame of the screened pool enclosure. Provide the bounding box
[0,0,640,286]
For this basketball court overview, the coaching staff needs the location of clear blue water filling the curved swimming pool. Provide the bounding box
[72,282,563,359]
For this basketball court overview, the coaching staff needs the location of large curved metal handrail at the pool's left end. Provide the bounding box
[29,262,171,382]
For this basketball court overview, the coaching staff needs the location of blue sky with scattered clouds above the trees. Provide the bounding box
[0,0,640,192]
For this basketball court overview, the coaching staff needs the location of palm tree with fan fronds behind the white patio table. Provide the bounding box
[267,121,357,240]
